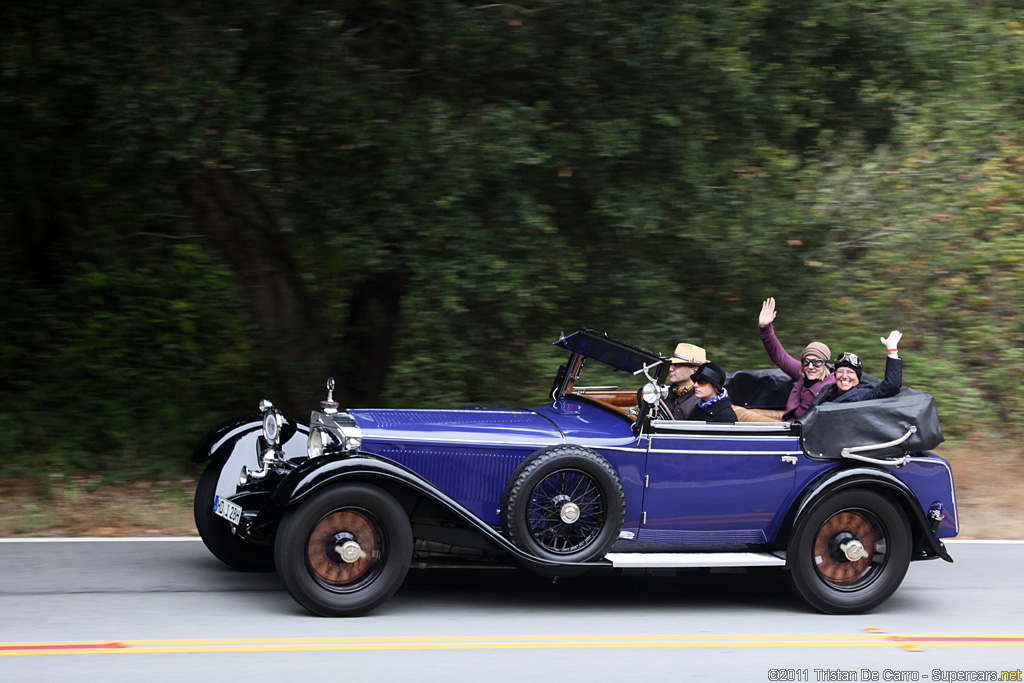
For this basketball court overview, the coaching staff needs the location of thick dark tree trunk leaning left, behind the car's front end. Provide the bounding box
[179,169,325,417]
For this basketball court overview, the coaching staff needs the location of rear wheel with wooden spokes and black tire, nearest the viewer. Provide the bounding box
[788,489,911,614]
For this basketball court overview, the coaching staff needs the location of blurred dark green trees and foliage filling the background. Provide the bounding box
[0,0,1024,468]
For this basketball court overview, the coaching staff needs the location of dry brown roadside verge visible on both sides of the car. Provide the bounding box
[0,437,1024,539]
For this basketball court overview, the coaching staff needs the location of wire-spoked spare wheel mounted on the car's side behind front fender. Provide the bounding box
[502,445,626,562]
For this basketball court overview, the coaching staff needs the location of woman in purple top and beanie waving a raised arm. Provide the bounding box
[758,297,836,422]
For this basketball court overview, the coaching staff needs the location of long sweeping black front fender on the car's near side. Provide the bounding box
[271,454,610,573]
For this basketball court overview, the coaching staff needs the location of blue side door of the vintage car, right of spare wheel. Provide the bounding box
[637,421,803,544]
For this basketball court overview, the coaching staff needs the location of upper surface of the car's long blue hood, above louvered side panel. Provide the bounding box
[349,408,565,447]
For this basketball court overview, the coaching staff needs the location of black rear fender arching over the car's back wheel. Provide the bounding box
[786,467,953,562]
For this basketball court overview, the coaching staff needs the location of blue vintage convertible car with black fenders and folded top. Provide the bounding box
[194,330,958,616]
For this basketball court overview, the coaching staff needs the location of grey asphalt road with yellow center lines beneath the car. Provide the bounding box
[0,540,1024,683]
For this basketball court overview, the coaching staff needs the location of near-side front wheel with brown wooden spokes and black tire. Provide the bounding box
[274,483,413,616]
